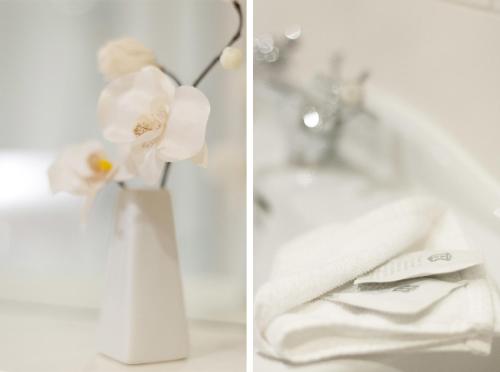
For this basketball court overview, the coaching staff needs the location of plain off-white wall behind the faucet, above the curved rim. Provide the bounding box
[254,0,500,179]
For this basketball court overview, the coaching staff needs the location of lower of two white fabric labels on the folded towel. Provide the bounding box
[322,274,467,315]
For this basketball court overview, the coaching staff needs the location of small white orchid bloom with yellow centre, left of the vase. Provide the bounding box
[48,141,119,197]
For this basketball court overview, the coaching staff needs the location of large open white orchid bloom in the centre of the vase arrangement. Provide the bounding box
[98,66,210,184]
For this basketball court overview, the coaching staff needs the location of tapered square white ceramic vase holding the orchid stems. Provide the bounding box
[98,190,189,364]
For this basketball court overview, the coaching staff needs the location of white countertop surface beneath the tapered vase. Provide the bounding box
[0,301,245,372]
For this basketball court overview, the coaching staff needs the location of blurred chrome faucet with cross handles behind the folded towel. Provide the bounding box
[254,26,376,165]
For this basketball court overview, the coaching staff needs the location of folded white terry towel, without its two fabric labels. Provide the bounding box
[255,198,498,363]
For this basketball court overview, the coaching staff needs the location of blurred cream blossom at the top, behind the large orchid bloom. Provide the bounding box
[97,38,157,81]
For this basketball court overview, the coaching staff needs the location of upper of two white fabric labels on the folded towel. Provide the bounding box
[354,250,482,284]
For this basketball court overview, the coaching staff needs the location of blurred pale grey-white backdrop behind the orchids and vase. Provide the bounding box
[0,0,245,321]
